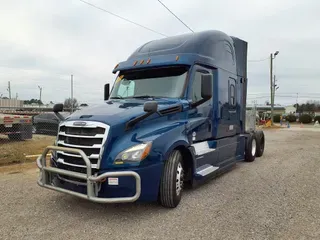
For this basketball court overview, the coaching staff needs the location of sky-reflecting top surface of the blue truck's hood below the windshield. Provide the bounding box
[66,99,180,126]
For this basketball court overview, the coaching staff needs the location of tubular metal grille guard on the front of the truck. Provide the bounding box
[37,146,141,203]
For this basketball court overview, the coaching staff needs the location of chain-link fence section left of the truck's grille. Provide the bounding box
[0,107,71,166]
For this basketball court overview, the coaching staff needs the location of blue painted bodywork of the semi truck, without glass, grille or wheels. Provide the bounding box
[48,31,252,201]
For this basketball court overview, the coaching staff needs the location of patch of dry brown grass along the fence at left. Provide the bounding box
[0,135,55,166]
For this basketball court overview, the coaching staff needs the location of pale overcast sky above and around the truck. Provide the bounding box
[0,0,320,105]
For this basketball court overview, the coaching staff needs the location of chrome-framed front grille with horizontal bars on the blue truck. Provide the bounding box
[56,121,110,169]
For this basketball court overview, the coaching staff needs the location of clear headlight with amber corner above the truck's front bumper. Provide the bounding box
[114,142,152,164]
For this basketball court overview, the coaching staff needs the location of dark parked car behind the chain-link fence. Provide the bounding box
[32,112,70,135]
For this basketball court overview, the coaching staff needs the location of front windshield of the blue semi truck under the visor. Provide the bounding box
[110,67,188,99]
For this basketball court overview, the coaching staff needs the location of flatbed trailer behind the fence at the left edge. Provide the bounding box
[0,114,32,141]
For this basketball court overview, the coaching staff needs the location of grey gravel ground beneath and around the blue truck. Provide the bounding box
[0,129,320,240]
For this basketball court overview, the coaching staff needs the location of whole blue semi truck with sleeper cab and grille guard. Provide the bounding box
[37,30,265,208]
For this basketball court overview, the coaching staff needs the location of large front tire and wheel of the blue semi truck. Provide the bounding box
[159,150,184,208]
